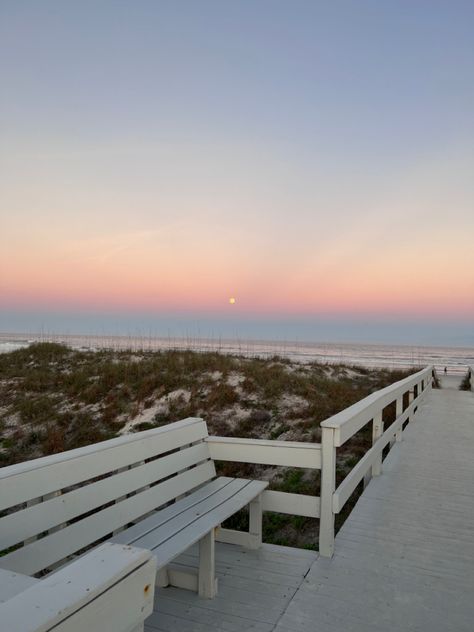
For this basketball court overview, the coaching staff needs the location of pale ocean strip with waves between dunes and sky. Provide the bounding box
[0,333,474,373]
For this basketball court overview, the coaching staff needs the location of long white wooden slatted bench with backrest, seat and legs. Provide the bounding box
[0,418,267,598]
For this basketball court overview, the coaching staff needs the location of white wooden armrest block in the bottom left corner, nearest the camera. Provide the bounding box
[0,543,156,632]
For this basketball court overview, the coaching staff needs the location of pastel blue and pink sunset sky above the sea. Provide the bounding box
[0,0,474,345]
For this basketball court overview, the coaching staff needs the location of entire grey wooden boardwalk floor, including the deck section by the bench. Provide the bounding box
[145,376,474,632]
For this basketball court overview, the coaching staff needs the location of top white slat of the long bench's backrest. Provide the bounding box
[0,418,208,511]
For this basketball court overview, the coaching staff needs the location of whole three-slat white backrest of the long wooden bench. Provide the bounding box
[0,418,216,575]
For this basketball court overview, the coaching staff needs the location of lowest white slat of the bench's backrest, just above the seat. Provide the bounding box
[1,461,215,575]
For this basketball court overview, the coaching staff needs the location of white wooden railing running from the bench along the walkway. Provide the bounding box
[207,366,434,557]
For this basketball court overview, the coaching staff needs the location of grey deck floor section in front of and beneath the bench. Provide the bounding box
[145,543,317,632]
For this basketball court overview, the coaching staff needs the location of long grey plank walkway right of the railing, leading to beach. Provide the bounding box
[275,379,474,632]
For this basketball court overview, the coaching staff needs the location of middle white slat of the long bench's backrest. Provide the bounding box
[0,442,209,550]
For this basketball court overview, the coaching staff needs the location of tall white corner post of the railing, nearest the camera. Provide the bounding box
[319,428,336,557]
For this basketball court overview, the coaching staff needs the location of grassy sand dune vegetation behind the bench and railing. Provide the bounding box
[0,343,415,548]
